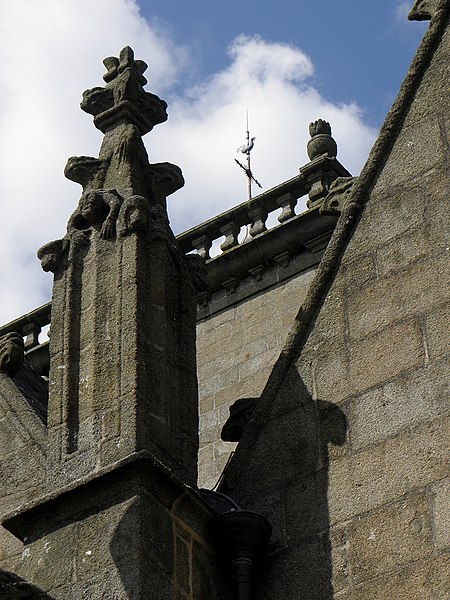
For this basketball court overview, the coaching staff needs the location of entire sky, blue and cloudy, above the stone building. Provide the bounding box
[0,0,427,323]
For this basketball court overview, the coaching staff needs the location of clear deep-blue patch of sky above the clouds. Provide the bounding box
[138,0,426,127]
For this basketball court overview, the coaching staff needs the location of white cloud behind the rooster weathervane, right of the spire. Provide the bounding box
[154,36,375,232]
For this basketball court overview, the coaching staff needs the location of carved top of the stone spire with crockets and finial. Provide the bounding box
[38,47,184,273]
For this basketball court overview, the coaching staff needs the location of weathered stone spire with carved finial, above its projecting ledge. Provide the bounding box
[38,47,201,485]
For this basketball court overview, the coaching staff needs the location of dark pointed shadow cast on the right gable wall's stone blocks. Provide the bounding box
[226,368,347,600]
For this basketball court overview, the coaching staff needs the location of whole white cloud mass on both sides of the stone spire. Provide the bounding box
[0,0,374,323]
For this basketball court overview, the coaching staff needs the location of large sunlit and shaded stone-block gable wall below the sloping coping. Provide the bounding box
[231,16,450,600]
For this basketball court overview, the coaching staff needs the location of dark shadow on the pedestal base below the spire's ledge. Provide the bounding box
[109,490,231,600]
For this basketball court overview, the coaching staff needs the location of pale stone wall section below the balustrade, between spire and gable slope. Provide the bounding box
[197,270,314,488]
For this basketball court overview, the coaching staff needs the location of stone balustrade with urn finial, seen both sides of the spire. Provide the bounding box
[0,119,350,375]
